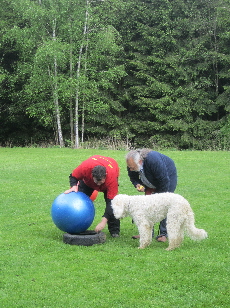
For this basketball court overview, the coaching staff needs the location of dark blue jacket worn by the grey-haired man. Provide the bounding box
[128,151,177,193]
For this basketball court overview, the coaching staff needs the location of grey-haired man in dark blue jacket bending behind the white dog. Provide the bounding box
[126,149,177,242]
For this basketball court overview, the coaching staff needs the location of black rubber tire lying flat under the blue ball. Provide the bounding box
[63,230,106,246]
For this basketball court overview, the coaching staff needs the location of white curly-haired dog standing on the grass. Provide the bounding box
[112,193,208,250]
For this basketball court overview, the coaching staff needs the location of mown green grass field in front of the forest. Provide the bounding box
[0,148,230,308]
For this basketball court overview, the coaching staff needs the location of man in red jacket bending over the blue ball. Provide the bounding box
[65,155,120,237]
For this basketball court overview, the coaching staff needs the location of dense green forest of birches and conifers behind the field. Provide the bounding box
[0,0,230,150]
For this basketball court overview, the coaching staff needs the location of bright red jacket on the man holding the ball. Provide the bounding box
[72,155,119,199]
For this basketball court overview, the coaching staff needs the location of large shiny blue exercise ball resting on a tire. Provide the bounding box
[51,192,95,234]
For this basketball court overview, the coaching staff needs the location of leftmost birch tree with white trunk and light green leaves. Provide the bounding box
[21,0,83,147]
